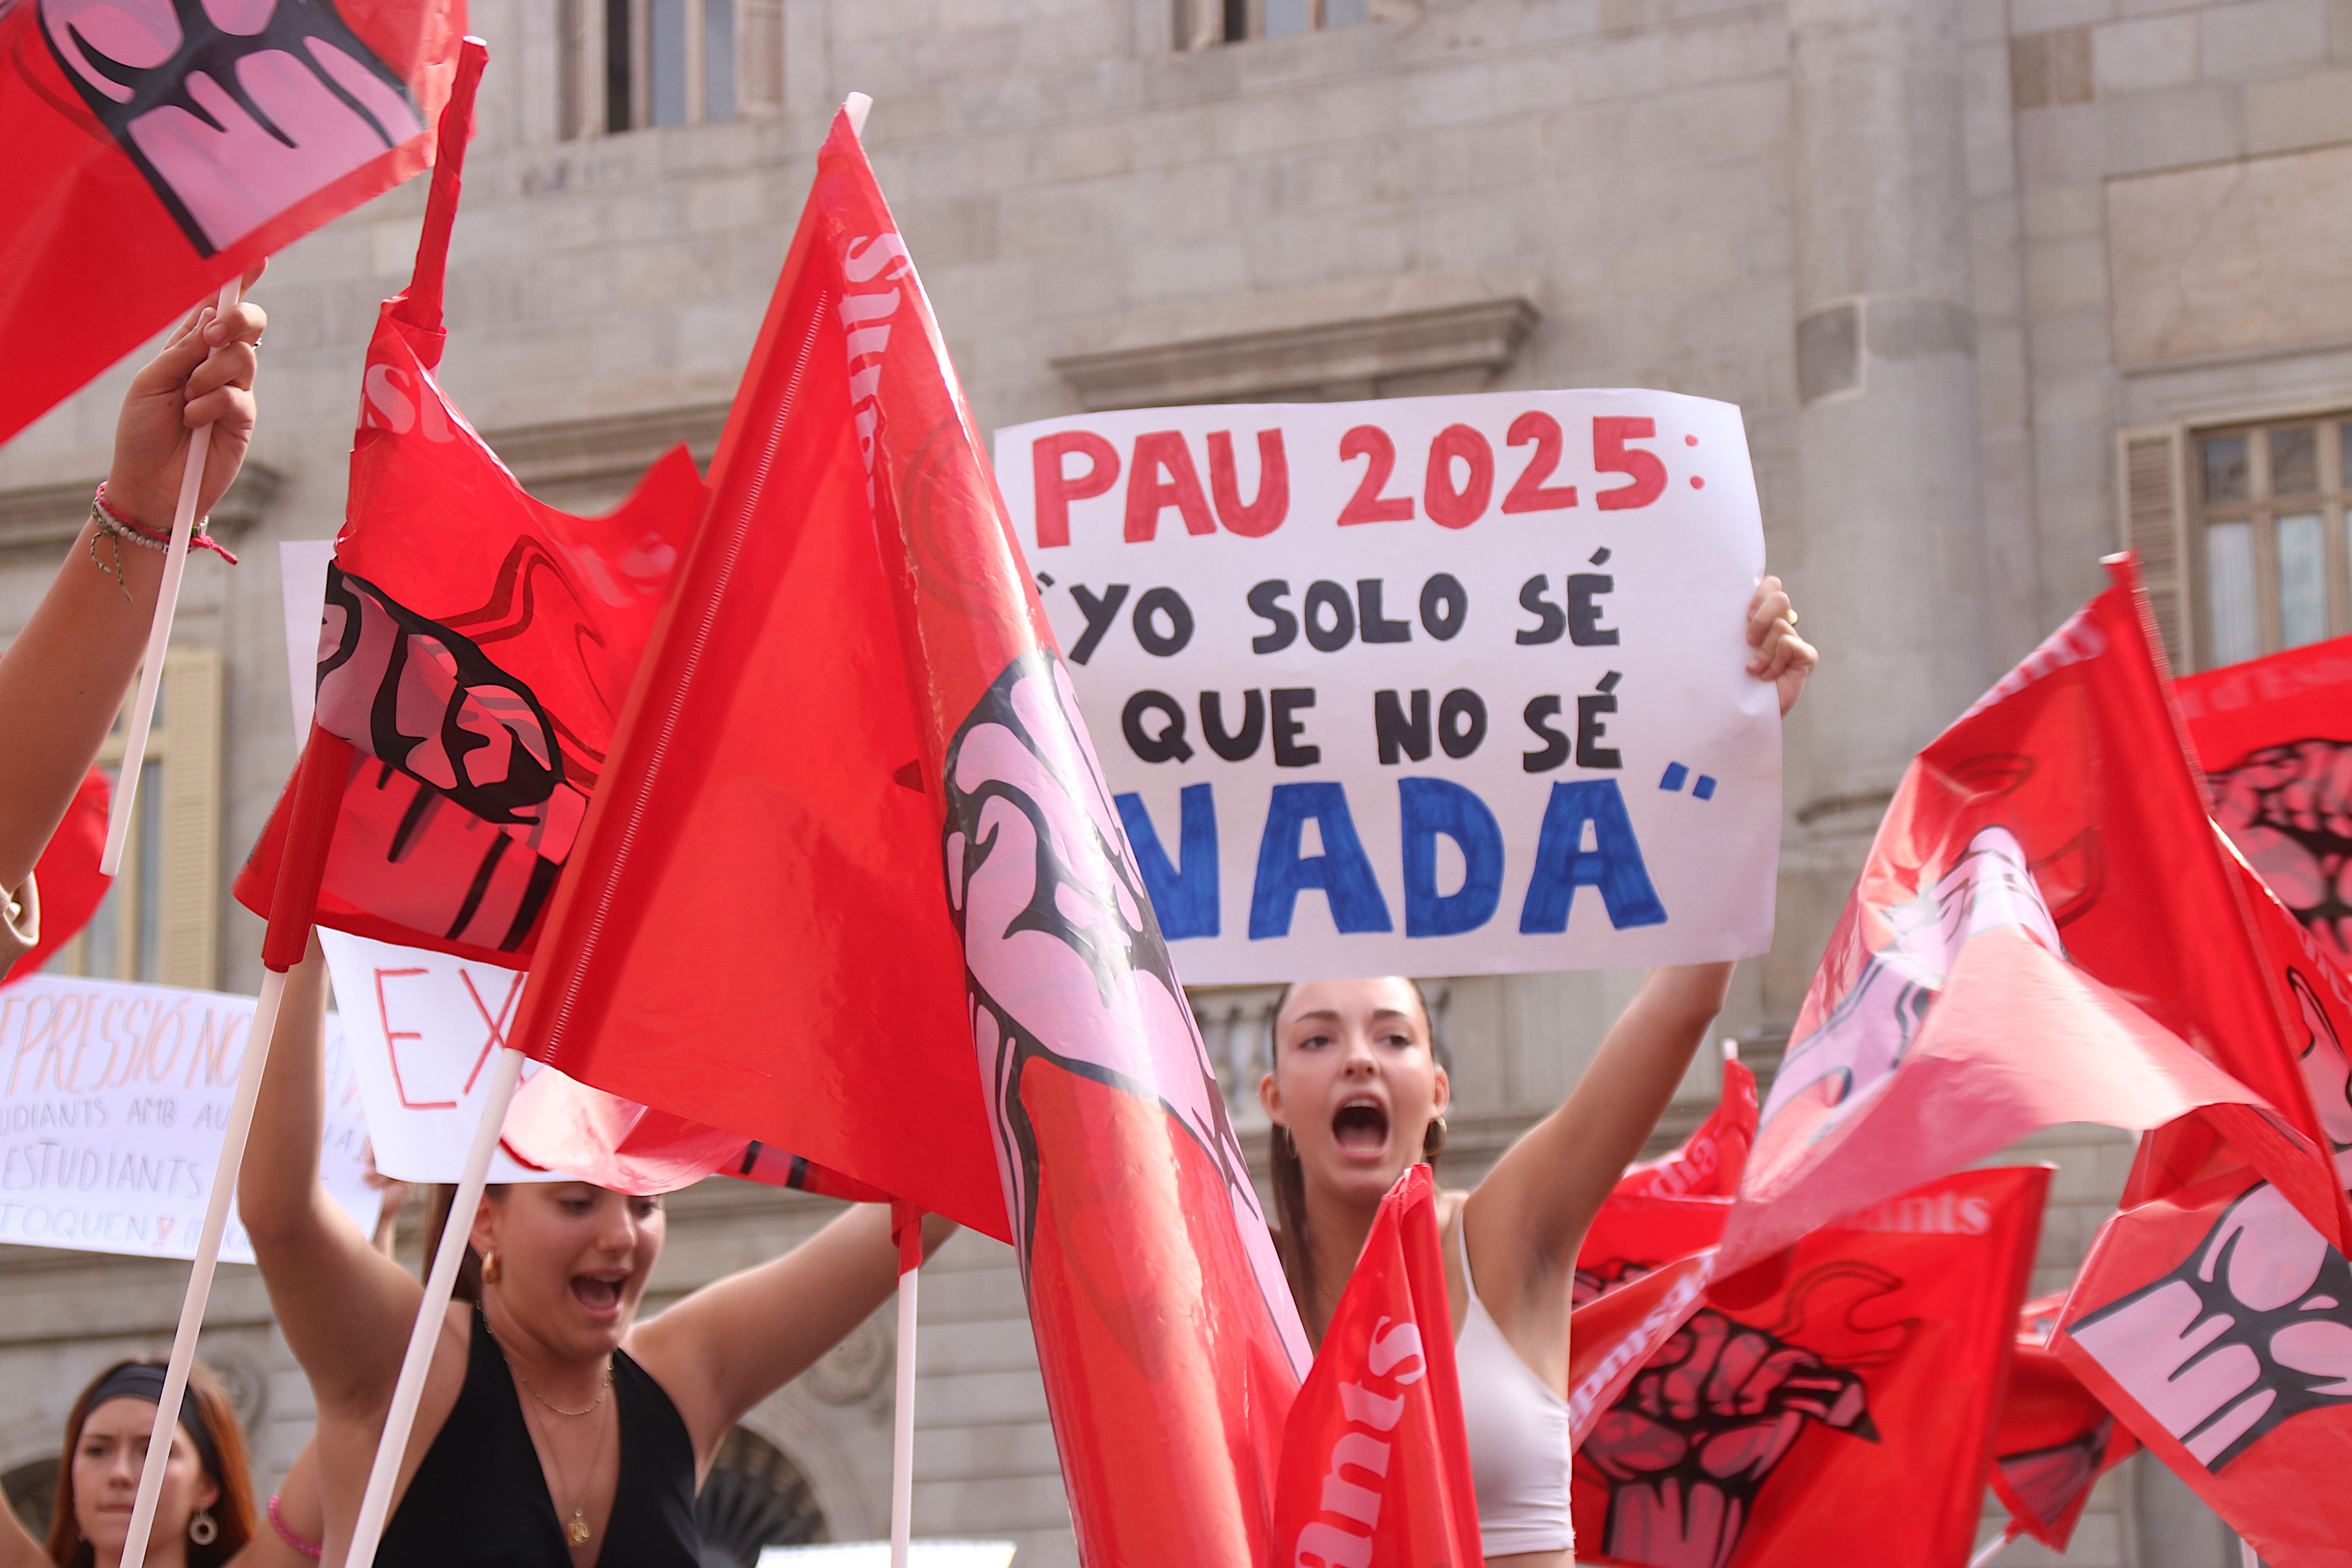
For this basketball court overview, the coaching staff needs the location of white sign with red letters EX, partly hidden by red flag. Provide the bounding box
[318,926,571,1183]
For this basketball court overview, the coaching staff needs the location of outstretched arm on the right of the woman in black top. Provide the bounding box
[630,1204,955,1464]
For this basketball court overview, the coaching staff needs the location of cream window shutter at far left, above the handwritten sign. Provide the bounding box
[155,649,224,990]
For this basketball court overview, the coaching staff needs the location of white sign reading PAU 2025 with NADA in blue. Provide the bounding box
[995,390,1781,985]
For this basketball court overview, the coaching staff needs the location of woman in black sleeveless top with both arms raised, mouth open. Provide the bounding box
[237,940,952,1568]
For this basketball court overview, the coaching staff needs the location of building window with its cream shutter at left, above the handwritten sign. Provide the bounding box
[47,649,221,990]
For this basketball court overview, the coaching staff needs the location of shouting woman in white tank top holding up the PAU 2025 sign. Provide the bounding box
[1259,578,1818,1568]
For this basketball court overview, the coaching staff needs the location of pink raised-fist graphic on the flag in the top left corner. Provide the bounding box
[37,0,426,256]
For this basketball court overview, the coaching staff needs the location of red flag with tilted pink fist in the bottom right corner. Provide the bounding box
[2056,865,2352,1566]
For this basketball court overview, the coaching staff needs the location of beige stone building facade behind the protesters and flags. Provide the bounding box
[0,0,2352,1568]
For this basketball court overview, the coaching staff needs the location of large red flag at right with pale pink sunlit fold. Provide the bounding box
[1722,557,2352,1272]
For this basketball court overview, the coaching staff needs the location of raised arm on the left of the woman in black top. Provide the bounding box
[237,933,423,1413]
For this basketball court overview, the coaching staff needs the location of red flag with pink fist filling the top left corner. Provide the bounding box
[0,0,466,442]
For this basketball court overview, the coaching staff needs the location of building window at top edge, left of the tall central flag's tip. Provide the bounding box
[557,0,783,137]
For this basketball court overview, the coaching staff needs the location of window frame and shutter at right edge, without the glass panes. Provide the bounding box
[2117,400,2352,670]
